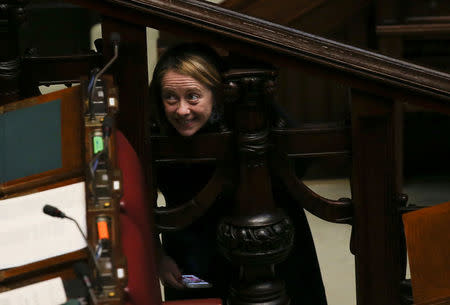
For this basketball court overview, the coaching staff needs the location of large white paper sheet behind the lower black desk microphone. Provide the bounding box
[0,182,86,268]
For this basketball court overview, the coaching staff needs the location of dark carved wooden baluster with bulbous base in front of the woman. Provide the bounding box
[218,71,294,305]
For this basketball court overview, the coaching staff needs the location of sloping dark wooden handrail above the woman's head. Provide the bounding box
[71,0,450,100]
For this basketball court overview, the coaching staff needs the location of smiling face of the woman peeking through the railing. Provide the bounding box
[161,70,213,136]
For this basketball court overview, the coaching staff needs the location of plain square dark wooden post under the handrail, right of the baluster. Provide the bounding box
[351,90,402,305]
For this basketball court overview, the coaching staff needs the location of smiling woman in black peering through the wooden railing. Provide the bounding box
[152,44,326,305]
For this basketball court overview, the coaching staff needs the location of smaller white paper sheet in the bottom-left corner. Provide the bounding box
[0,277,67,305]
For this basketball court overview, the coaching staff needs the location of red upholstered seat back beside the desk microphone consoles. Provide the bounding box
[116,132,222,305]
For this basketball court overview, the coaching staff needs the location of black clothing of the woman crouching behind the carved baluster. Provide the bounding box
[157,164,326,305]
